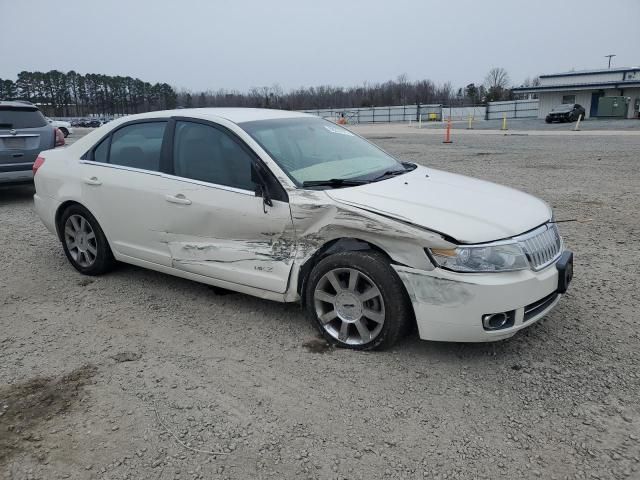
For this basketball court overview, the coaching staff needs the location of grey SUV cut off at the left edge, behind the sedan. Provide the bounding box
[0,101,65,184]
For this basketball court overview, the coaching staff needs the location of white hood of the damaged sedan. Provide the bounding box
[326,166,552,243]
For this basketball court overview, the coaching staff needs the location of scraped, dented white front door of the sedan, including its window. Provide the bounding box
[158,121,295,293]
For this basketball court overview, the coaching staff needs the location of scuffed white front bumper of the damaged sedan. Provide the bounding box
[393,253,562,342]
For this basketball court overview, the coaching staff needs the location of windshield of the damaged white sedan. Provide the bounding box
[240,118,405,187]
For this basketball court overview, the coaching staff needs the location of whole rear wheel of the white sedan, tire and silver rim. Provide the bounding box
[58,204,115,275]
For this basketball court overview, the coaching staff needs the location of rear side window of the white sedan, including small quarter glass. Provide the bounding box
[106,122,167,171]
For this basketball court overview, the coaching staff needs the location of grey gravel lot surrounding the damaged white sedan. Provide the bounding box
[0,127,640,480]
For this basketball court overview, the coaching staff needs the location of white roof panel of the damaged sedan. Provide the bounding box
[112,108,313,123]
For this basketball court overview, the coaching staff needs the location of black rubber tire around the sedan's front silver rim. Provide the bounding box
[304,250,413,350]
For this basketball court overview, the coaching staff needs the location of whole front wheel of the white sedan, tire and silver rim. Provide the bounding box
[304,250,413,350]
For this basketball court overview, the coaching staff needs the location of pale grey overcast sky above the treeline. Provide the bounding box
[0,0,640,91]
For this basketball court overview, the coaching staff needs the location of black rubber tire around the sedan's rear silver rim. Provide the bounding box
[58,204,115,275]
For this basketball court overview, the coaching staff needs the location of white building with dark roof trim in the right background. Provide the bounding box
[513,67,640,118]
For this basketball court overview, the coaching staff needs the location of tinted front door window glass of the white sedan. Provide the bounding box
[173,121,255,191]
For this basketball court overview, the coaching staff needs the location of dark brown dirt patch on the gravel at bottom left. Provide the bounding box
[0,365,97,465]
